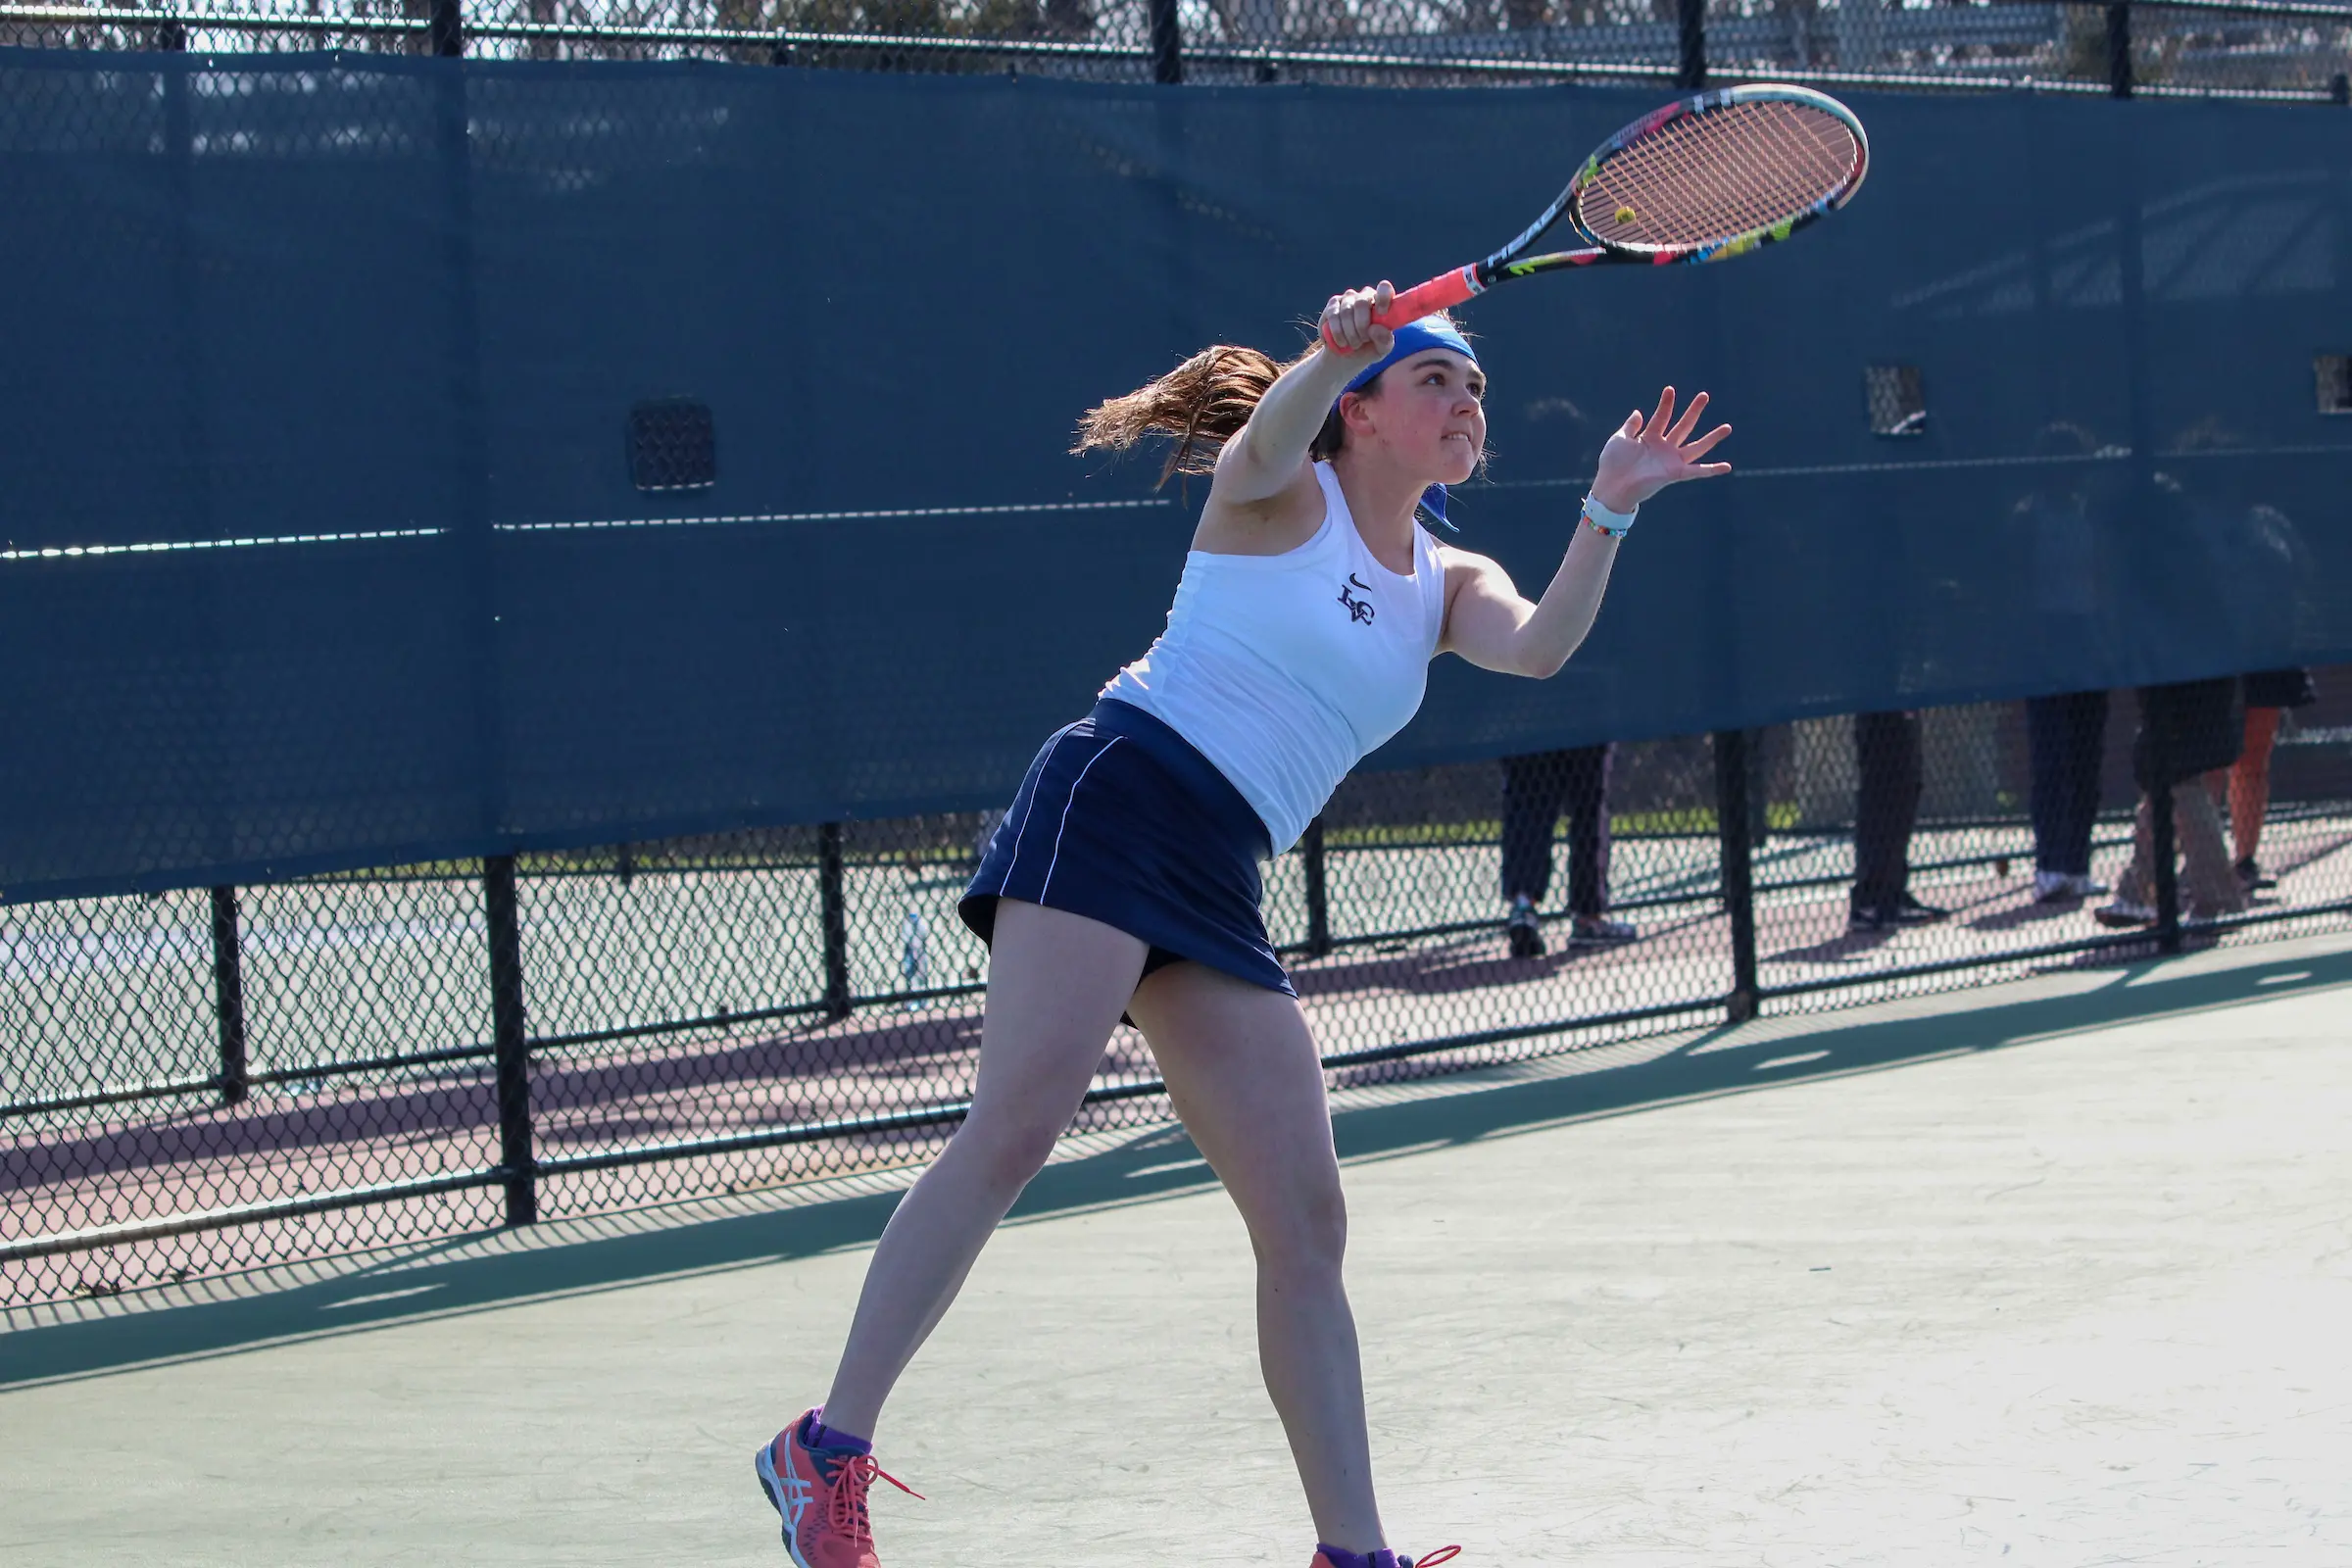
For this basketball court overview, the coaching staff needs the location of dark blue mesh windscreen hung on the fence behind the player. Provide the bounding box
[0,54,2352,898]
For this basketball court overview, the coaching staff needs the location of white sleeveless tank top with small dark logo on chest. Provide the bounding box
[1103,464,1446,854]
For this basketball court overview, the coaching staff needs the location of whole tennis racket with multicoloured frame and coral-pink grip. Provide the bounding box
[1327,84,1870,336]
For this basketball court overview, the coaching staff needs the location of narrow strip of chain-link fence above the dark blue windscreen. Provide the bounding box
[14,0,2352,101]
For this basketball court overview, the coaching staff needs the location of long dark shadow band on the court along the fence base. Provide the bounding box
[0,953,2352,1387]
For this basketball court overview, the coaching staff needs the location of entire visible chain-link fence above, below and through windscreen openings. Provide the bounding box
[0,0,2352,1304]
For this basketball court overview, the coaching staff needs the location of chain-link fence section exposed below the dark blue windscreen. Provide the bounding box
[0,667,2352,1304]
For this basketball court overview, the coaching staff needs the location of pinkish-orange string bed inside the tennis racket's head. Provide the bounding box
[1576,99,1860,249]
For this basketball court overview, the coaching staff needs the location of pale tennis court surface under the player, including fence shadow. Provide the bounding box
[0,938,2352,1568]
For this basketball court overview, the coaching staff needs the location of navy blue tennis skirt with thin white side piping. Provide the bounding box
[957,698,1298,997]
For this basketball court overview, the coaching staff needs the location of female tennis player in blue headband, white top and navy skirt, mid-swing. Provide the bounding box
[758,282,1731,1568]
